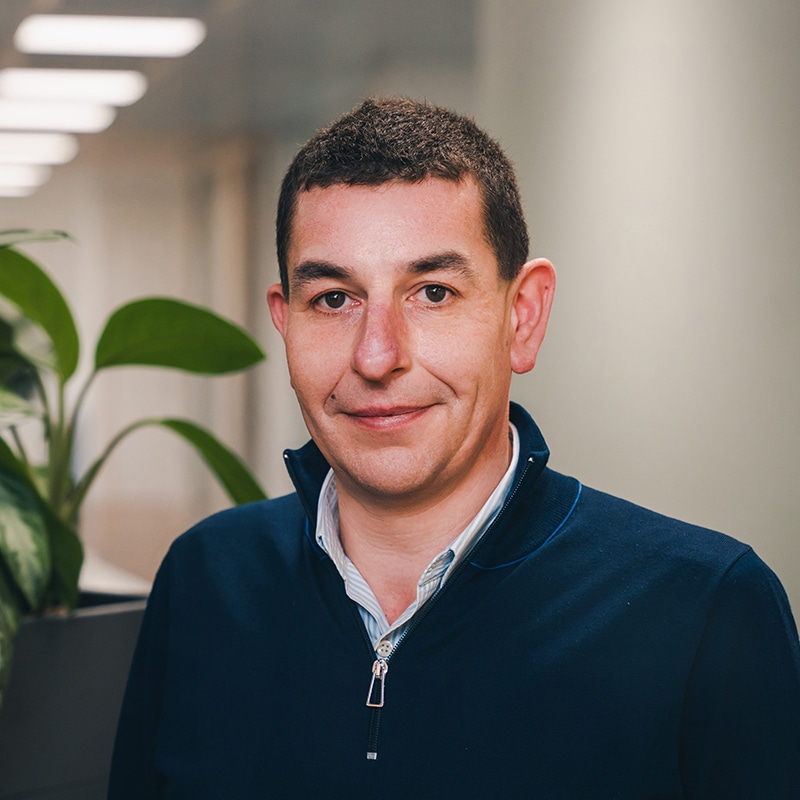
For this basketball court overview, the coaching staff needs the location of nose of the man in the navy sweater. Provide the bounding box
[353,303,410,382]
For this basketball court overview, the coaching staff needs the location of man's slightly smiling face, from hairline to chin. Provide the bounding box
[269,179,528,510]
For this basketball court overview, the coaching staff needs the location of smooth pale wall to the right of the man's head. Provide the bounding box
[479,0,800,608]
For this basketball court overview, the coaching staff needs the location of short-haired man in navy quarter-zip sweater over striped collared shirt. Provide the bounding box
[110,100,800,800]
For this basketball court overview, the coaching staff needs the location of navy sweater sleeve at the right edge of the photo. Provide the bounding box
[681,550,800,800]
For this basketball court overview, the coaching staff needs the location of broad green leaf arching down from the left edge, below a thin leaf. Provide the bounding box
[0,247,80,382]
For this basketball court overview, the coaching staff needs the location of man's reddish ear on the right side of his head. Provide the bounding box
[510,258,556,374]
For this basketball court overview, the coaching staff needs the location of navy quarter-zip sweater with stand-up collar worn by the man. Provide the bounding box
[109,406,800,800]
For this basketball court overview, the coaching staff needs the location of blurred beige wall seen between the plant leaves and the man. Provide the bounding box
[0,131,270,578]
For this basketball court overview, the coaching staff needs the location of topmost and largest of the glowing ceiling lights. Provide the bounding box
[14,14,206,57]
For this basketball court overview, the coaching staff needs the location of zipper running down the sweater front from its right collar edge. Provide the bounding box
[362,456,536,761]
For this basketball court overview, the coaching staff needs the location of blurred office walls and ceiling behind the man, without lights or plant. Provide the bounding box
[0,0,800,610]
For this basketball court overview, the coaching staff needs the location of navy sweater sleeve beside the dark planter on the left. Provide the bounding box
[108,559,169,800]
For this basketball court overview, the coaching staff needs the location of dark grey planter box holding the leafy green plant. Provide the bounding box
[0,594,145,800]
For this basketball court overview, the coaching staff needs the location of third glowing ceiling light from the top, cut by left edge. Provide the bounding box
[0,98,116,133]
